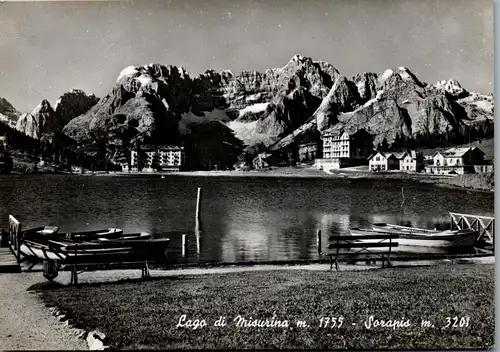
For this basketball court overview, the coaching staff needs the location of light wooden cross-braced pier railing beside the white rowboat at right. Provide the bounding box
[450,213,495,249]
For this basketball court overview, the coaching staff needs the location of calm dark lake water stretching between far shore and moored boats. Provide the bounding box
[0,175,494,262]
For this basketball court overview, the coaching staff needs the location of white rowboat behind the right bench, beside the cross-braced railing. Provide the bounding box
[351,228,479,248]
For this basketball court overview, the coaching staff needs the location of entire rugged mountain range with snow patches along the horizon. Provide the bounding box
[0,55,494,169]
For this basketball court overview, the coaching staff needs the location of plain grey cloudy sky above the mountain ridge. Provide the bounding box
[0,0,494,111]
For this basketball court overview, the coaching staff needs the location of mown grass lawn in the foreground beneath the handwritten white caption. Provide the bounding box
[34,265,495,349]
